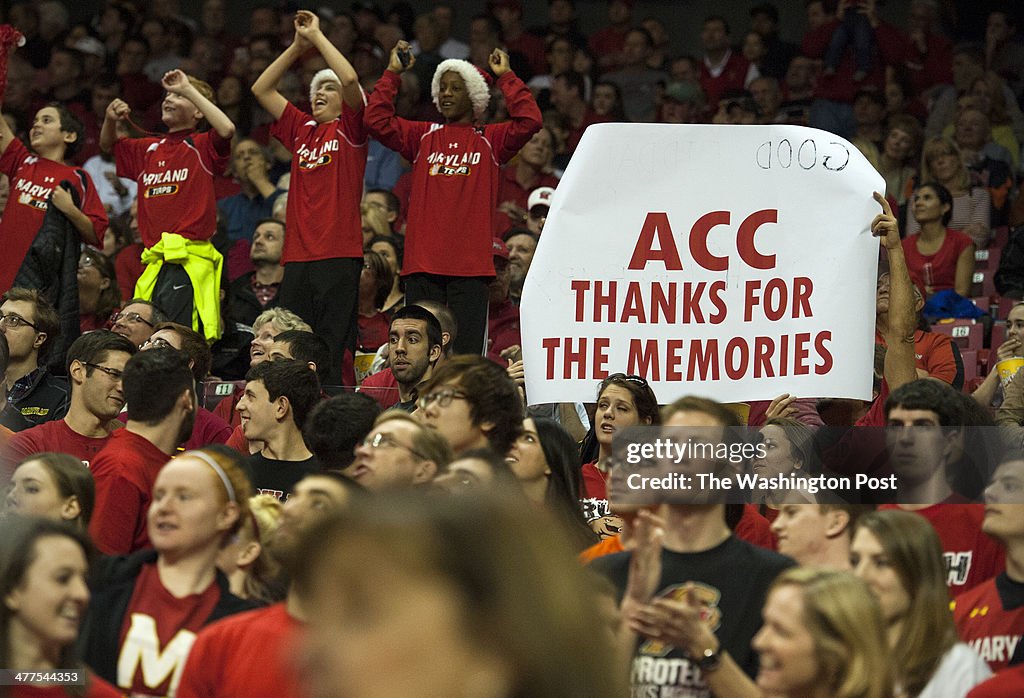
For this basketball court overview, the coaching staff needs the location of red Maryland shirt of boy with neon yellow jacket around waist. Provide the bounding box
[114,130,231,248]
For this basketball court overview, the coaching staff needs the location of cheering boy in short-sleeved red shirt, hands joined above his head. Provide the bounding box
[252,10,367,384]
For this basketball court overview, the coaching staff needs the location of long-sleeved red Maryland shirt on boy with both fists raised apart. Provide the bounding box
[367,71,541,276]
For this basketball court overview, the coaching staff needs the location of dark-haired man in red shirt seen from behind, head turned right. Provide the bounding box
[89,348,197,555]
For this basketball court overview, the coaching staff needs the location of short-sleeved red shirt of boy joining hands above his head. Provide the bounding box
[270,103,368,263]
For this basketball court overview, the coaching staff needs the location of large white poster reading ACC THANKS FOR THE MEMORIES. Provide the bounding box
[522,124,885,404]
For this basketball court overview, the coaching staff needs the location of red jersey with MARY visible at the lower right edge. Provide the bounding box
[952,573,1024,671]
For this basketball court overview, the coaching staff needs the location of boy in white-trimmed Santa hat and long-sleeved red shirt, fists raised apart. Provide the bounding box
[367,41,542,354]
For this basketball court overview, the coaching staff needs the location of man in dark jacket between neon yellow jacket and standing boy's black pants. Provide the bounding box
[224,218,285,326]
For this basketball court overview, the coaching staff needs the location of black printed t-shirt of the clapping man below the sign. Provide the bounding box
[591,536,794,698]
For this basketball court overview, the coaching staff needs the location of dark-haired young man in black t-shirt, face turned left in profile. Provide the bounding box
[238,359,321,500]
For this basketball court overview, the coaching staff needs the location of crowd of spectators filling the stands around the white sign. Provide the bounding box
[0,0,1024,698]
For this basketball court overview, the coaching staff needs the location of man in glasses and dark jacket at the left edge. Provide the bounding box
[0,288,69,427]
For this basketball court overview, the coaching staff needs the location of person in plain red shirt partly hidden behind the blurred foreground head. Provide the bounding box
[177,471,362,698]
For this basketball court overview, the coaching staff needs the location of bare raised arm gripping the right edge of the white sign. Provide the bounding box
[871,191,918,392]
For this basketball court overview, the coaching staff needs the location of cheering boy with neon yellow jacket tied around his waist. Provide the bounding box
[99,71,234,340]
